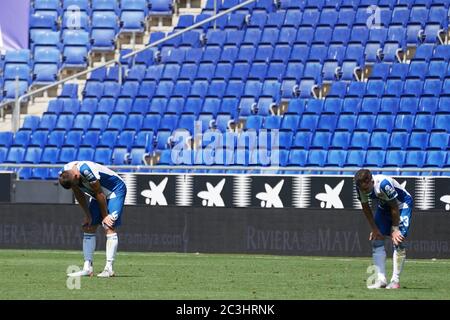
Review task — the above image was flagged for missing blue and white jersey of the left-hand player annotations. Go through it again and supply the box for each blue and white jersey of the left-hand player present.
[64,161,127,199]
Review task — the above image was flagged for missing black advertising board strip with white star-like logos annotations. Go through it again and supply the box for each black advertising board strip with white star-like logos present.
[6,173,450,213]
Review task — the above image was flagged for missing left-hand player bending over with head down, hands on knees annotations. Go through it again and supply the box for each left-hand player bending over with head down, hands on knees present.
[59,161,127,278]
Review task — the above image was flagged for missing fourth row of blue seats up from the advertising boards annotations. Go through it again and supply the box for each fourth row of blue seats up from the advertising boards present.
[17,96,450,117]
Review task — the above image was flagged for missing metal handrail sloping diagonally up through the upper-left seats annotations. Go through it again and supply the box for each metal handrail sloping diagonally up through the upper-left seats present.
[0,0,258,132]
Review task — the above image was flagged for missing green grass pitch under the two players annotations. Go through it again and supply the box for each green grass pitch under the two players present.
[0,250,450,300]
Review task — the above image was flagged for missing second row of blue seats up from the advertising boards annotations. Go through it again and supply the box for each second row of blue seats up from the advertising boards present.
[0,123,450,152]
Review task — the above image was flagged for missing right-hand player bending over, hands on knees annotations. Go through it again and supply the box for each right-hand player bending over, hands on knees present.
[355,169,413,289]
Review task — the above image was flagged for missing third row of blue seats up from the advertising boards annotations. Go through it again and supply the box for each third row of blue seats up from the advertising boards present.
[4,110,450,134]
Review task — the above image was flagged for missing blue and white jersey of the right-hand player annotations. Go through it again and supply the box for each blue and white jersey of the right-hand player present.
[356,174,413,209]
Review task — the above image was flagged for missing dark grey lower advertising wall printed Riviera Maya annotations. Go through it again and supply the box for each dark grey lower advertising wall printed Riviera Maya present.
[0,204,450,258]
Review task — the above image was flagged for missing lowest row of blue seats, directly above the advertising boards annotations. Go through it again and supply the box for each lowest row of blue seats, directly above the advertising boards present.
[0,147,450,179]
